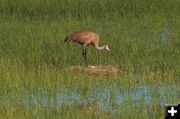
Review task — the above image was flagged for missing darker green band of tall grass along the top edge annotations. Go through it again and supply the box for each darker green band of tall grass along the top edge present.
[0,0,180,19]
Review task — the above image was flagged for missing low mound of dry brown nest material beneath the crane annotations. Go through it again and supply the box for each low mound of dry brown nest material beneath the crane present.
[68,65,119,74]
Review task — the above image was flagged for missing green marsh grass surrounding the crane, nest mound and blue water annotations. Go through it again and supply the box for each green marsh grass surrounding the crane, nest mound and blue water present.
[0,0,180,119]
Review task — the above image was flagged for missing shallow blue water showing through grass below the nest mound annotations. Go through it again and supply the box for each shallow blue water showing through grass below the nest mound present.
[0,84,178,112]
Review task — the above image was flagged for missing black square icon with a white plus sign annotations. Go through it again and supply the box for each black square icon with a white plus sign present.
[165,104,180,119]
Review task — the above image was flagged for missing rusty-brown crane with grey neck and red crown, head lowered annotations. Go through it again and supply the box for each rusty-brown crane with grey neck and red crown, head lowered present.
[64,30,111,63]
